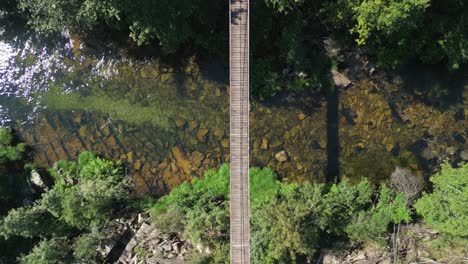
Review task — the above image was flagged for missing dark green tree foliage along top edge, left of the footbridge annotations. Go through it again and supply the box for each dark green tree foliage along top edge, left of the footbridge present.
[19,0,220,50]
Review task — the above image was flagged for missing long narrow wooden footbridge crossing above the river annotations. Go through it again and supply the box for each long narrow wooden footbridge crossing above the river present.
[229,0,250,264]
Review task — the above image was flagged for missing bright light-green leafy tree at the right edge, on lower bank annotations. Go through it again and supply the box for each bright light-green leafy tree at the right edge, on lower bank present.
[414,163,468,239]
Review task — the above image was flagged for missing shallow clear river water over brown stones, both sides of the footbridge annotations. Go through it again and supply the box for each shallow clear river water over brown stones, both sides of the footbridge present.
[0,15,468,195]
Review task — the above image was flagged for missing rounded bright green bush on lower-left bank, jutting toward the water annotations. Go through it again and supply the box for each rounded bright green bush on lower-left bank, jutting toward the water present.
[40,152,129,229]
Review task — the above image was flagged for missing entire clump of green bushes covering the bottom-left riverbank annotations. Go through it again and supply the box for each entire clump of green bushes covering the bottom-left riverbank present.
[0,152,130,263]
